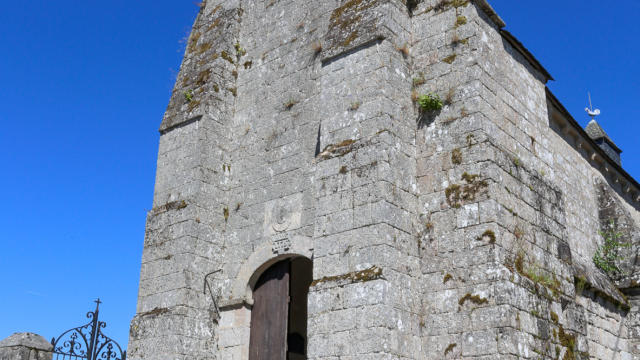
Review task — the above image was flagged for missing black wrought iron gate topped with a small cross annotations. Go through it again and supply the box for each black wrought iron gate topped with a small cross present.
[51,299,127,360]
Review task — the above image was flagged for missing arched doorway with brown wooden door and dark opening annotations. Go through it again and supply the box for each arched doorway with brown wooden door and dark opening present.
[249,257,312,360]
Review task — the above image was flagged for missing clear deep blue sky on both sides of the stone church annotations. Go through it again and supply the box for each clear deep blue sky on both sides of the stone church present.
[0,0,640,346]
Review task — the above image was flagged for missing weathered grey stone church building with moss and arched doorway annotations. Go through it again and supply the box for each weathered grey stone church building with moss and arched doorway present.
[129,0,640,360]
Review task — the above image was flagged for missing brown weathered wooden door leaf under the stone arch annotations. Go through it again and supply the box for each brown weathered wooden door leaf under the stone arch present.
[249,260,290,360]
